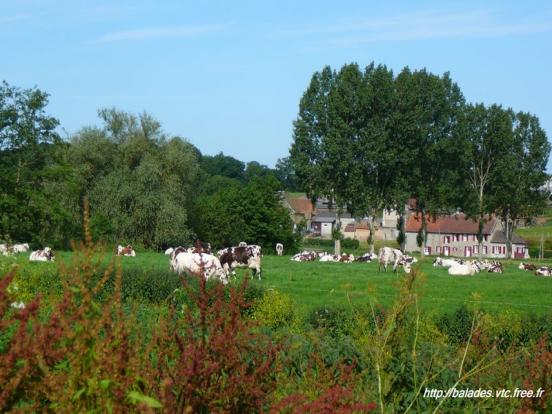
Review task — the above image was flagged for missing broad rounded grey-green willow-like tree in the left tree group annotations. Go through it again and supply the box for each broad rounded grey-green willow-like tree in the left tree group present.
[70,109,199,248]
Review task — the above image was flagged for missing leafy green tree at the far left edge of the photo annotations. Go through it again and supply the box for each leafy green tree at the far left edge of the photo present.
[0,82,80,246]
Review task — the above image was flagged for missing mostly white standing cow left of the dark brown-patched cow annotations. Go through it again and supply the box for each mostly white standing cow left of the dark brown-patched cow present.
[169,251,228,284]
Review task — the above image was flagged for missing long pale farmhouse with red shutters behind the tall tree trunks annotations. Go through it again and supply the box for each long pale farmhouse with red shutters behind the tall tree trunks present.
[405,213,529,259]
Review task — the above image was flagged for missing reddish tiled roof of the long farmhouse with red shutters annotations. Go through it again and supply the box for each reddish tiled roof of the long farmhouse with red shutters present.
[405,213,496,234]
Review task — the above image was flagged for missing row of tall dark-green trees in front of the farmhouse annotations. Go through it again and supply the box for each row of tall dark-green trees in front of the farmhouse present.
[289,63,550,253]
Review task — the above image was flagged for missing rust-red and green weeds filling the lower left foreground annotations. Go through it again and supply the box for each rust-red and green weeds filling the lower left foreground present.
[0,225,374,413]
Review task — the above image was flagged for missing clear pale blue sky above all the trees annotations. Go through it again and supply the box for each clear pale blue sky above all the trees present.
[0,0,552,171]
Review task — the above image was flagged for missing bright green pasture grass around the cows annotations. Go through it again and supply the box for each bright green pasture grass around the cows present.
[0,252,552,313]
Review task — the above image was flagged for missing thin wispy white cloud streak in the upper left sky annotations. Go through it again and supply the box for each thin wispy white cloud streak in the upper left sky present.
[94,24,227,43]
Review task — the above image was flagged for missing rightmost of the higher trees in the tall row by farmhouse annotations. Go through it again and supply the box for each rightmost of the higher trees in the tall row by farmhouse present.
[394,68,465,253]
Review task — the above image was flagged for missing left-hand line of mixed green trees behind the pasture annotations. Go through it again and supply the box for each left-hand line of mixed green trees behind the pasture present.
[0,82,296,249]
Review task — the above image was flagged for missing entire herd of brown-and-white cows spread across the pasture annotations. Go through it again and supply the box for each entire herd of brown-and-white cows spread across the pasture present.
[0,241,552,284]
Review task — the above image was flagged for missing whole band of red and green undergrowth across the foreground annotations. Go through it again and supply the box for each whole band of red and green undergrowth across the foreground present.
[0,233,552,413]
